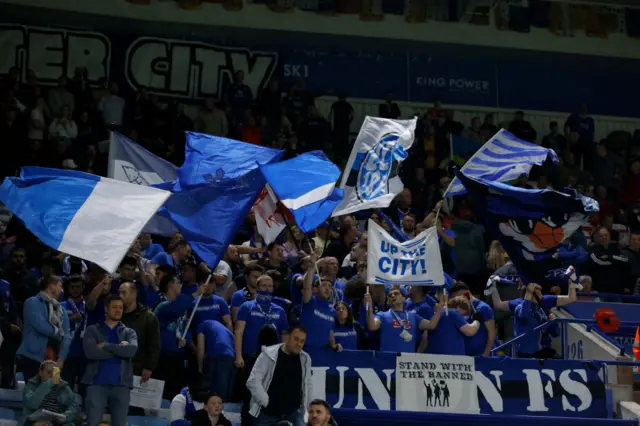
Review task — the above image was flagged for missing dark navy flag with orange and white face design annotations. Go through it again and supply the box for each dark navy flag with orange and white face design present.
[456,170,599,285]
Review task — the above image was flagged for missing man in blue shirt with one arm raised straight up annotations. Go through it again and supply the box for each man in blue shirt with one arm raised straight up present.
[300,253,342,352]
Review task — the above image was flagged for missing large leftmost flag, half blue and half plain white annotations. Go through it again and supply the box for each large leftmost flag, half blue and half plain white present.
[0,167,171,273]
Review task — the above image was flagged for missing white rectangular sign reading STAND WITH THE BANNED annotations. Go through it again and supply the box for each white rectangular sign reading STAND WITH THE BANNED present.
[396,353,480,414]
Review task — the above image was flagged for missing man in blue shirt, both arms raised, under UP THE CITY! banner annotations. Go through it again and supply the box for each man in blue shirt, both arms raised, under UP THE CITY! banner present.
[363,287,442,353]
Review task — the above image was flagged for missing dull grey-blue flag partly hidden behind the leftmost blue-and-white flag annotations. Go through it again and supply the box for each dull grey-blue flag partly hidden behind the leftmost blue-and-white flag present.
[107,132,178,236]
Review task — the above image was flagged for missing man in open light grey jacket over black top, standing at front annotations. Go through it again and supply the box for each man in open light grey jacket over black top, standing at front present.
[247,327,312,426]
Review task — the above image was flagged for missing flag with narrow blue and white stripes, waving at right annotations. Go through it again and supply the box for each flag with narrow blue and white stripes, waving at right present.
[443,129,560,197]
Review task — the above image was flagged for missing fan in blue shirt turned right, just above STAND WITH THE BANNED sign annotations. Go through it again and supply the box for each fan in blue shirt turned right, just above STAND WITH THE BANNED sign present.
[427,296,480,355]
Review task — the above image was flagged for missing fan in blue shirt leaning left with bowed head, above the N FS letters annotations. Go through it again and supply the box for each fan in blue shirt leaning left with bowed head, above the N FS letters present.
[449,281,496,356]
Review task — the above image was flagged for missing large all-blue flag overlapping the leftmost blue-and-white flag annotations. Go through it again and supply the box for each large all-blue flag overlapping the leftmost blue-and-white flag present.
[154,132,284,268]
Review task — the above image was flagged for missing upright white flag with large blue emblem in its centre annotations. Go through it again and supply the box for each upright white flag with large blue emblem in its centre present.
[333,117,417,216]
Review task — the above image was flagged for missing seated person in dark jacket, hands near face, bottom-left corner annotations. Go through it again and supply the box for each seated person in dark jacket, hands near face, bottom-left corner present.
[20,361,78,426]
